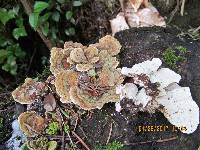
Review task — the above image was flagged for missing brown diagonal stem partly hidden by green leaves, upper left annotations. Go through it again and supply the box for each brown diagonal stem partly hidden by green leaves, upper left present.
[20,0,53,50]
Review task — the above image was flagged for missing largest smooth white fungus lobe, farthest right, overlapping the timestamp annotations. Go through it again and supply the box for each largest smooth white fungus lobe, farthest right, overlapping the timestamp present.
[157,87,199,134]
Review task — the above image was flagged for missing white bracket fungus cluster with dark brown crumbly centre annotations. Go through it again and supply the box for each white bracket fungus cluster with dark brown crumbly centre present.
[116,58,199,134]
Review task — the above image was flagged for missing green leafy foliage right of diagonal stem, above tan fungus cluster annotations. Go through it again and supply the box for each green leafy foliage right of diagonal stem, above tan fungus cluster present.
[29,0,82,44]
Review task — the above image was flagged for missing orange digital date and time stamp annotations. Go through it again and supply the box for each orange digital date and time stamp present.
[137,125,187,132]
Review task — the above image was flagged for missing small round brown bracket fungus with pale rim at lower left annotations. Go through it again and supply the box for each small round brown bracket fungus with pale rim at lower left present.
[18,111,45,137]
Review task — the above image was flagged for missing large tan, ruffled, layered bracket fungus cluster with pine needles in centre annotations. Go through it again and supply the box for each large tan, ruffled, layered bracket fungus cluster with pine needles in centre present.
[50,35,123,110]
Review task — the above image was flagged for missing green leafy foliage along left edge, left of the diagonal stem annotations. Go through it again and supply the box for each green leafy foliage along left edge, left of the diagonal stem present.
[0,5,27,75]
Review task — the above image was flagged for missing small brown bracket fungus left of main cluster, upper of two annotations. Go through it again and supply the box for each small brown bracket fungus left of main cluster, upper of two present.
[12,78,48,104]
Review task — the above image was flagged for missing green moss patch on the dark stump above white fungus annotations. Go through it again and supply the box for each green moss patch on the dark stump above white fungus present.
[163,46,188,69]
